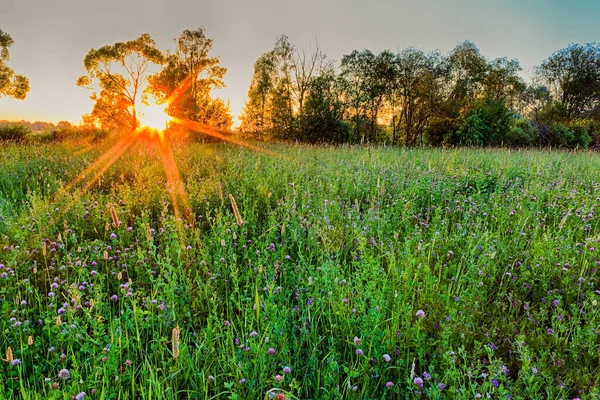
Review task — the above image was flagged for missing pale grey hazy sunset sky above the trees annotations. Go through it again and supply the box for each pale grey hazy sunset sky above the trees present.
[0,0,600,123]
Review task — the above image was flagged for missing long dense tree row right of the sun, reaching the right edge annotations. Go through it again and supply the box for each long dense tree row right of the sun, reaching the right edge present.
[240,35,600,148]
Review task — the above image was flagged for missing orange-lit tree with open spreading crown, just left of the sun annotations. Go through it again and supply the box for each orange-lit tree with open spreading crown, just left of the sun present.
[77,33,164,130]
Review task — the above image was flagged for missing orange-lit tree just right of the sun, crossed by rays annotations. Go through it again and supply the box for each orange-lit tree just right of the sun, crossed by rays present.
[150,27,233,128]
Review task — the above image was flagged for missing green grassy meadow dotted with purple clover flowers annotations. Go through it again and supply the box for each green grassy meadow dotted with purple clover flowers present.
[0,137,600,399]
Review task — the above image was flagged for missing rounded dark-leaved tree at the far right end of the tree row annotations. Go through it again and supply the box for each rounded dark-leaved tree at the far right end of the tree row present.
[537,43,600,121]
